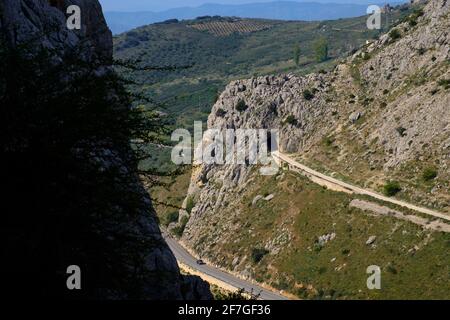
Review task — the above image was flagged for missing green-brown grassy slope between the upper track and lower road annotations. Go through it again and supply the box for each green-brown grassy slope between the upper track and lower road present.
[195,173,450,299]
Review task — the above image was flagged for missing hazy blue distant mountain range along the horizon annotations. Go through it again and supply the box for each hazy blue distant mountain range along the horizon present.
[105,0,398,34]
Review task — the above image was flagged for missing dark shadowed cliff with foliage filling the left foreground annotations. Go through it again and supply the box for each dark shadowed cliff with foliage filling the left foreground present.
[0,0,211,299]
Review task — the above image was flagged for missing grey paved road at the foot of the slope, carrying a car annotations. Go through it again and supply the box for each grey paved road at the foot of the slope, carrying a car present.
[163,233,288,300]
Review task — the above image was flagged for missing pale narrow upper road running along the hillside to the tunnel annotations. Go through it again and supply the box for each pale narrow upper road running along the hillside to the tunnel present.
[272,151,450,221]
